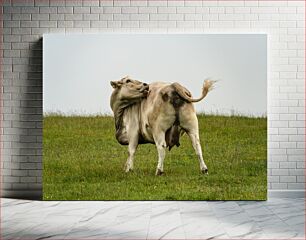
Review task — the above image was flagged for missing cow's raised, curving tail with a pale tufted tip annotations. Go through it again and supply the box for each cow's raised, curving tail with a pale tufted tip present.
[172,79,216,103]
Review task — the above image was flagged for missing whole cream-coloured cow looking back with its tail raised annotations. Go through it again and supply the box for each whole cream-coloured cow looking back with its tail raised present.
[110,76,214,175]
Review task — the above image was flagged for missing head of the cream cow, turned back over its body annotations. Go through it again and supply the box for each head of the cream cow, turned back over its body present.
[110,76,149,102]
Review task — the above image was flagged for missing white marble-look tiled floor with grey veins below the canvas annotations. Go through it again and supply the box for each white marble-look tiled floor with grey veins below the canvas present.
[1,198,305,240]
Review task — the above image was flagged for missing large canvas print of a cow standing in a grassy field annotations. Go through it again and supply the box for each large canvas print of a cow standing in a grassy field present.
[43,33,267,200]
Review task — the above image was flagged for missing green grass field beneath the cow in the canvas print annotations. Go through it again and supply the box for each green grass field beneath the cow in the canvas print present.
[43,115,267,200]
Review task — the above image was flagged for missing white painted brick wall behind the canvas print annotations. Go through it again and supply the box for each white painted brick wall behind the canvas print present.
[1,0,305,199]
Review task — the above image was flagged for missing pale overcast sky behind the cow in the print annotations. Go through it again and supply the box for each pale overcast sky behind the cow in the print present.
[43,33,267,116]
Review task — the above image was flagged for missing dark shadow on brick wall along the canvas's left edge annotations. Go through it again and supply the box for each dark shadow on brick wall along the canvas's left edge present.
[13,38,43,200]
